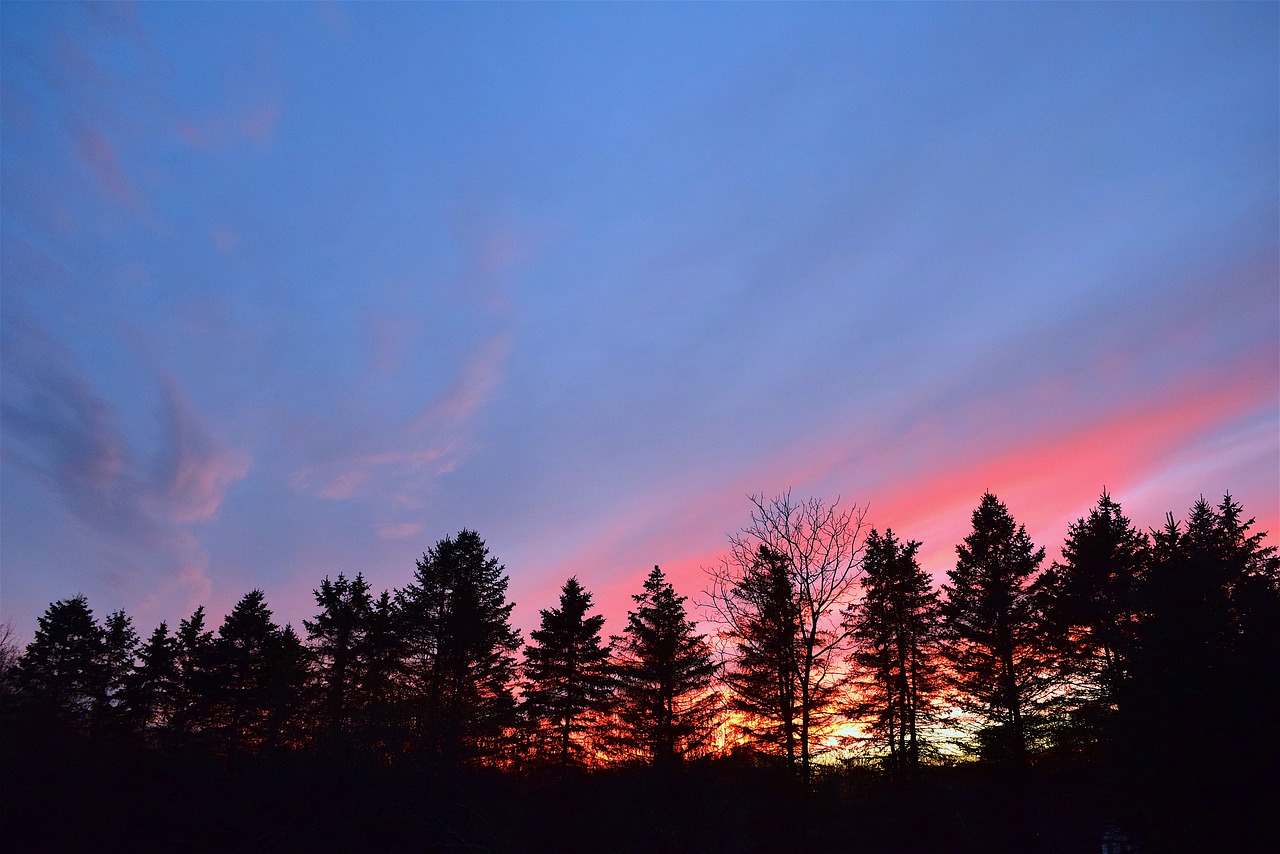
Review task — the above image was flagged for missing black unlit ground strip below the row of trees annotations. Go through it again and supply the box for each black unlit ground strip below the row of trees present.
[0,729,1280,854]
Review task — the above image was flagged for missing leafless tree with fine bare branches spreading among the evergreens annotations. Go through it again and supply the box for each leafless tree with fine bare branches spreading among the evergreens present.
[707,492,867,780]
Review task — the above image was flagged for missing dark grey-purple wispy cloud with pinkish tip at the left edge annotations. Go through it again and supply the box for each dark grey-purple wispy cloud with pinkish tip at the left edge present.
[0,312,250,602]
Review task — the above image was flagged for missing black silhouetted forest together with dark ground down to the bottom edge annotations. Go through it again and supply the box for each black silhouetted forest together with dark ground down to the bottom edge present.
[0,492,1280,853]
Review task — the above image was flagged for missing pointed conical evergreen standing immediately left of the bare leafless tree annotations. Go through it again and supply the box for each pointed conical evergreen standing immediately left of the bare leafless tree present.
[613,566,718,766]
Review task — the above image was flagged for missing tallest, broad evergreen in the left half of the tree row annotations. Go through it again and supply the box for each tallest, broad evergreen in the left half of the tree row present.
[397,530,521,764]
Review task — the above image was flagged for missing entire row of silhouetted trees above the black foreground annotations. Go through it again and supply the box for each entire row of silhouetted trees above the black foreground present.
[3,492,1280,793]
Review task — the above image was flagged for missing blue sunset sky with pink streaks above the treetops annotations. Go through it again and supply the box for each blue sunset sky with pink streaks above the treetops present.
[0,3,1280,640]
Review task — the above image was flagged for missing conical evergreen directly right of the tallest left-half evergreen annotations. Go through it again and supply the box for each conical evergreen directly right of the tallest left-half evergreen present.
[524,577,613,764]
